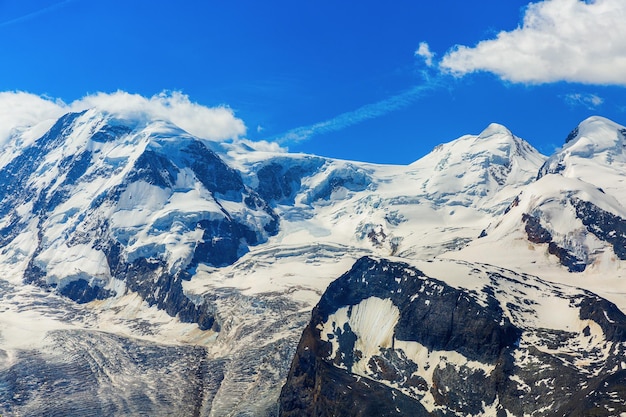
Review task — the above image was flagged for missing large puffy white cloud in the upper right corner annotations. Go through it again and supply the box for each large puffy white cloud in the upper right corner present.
[440,0,626,86]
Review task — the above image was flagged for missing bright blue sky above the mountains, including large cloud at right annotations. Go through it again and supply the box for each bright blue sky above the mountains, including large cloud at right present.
[0,0,626,164]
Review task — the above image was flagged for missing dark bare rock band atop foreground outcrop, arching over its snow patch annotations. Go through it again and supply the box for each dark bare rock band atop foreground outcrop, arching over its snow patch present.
[313,257,520,363]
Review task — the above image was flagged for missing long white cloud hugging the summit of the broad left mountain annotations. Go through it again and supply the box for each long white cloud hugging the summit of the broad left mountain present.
[71,91,246,141]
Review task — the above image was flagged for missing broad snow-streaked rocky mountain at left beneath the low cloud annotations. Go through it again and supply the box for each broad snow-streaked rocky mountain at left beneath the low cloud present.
[0,110,277,301]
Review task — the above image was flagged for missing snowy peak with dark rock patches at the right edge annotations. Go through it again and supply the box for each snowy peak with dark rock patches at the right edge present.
[446,117,626,292]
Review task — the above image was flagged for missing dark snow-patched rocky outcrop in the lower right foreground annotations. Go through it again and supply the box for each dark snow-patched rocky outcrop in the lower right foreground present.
[280,258,626,416]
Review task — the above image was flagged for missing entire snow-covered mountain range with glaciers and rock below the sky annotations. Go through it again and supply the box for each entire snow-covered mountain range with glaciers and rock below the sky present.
[0,108,626,416]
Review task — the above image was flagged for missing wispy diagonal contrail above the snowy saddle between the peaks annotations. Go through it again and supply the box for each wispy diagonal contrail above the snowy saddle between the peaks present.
[268,80,438,145]
